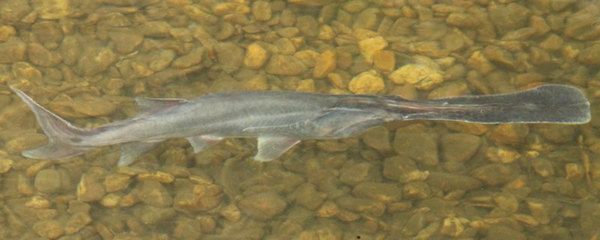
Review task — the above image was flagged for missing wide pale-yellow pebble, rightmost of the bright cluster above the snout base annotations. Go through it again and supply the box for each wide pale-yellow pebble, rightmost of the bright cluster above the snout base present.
[388,64,444,90]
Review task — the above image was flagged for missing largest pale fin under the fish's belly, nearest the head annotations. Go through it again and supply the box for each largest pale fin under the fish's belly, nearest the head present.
[254,137,300,162]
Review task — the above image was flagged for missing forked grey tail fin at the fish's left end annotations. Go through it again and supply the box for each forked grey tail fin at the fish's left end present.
[10,87,89,159]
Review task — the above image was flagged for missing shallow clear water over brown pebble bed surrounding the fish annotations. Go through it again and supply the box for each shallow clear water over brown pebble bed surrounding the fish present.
[0,0,600,240]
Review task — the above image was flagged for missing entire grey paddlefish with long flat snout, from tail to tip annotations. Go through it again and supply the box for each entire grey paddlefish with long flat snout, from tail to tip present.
[11,84,590,166]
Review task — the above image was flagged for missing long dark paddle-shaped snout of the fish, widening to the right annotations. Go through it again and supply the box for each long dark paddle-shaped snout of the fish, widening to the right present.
[386,84,591,124]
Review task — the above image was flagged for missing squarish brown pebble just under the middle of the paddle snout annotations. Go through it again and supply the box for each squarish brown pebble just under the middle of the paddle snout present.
[441,133,481,162]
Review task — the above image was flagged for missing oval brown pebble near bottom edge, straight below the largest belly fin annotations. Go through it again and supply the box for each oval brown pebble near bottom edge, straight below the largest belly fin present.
[239,192,287,221]
